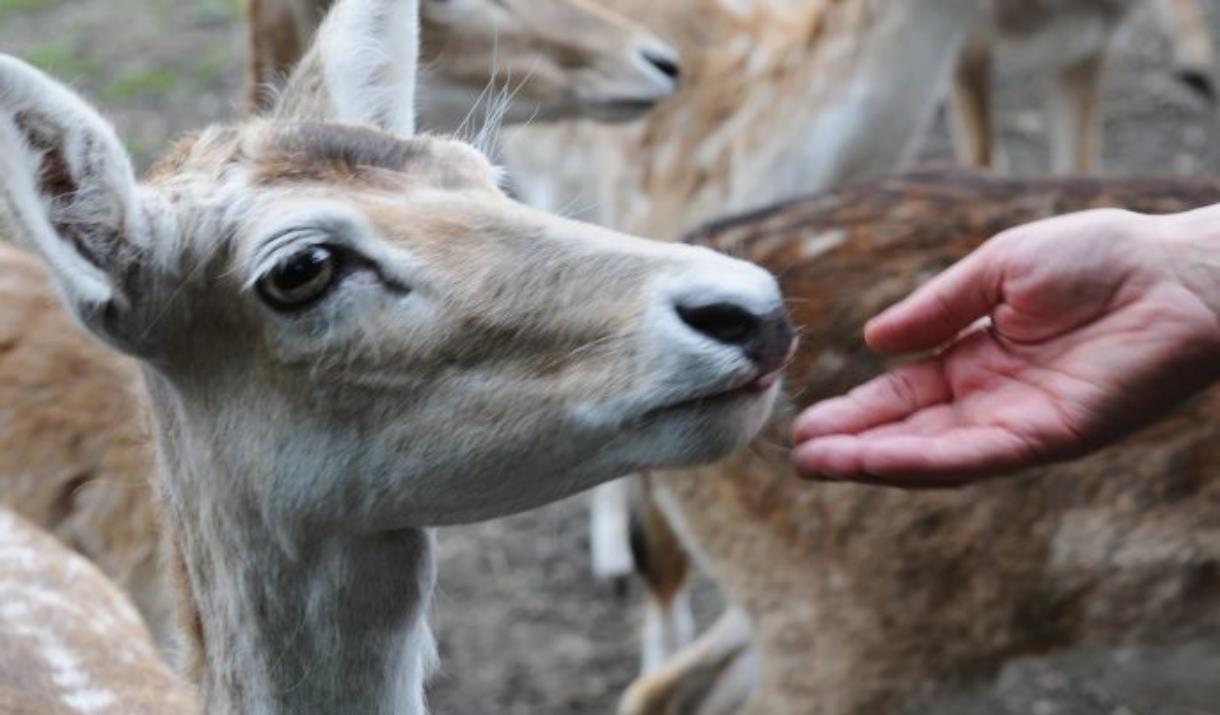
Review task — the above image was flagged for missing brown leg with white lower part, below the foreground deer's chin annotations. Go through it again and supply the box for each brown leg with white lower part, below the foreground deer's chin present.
[631,477,694,674]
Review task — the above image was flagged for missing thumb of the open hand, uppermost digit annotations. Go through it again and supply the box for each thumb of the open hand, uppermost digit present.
[864,237,1003,353]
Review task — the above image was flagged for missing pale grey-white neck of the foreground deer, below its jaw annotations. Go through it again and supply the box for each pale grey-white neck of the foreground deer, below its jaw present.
[150,373,436,715]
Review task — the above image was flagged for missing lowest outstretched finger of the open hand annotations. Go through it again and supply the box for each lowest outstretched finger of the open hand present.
[793,427,1046,480]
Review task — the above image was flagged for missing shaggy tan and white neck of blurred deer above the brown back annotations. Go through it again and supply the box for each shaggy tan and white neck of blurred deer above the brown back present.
[604,0,977,238]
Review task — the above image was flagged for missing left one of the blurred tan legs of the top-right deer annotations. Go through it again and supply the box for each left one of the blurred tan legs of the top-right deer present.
[953,30,994,168]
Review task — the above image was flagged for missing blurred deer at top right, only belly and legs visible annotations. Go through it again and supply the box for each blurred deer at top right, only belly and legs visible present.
[953,0,1214,174]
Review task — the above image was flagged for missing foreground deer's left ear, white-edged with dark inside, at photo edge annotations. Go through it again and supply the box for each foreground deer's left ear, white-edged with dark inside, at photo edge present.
[0,55,145,351]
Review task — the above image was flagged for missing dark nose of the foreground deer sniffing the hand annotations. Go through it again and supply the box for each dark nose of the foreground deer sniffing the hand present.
[676,301,795,373]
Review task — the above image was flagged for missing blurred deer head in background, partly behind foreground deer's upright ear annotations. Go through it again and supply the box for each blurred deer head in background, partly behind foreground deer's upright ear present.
[245,0,681,128]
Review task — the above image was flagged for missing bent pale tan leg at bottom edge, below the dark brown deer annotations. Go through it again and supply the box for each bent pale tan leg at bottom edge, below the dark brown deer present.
[619,608,759,715]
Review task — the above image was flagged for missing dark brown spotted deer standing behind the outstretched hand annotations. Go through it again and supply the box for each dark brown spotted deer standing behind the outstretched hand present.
[620,171,1220,715]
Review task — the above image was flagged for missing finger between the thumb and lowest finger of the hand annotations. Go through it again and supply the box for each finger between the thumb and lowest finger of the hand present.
[793,359,950,443]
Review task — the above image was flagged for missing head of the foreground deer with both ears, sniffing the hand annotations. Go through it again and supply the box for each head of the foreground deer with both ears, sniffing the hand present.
[0,0,791,526]
